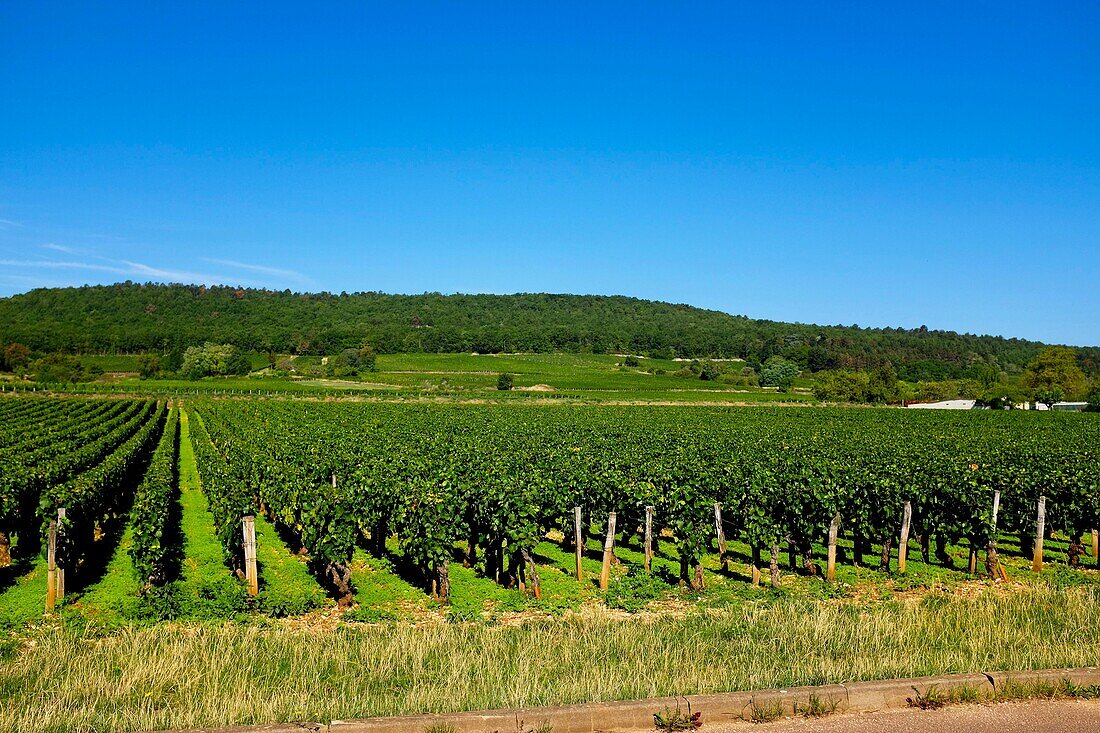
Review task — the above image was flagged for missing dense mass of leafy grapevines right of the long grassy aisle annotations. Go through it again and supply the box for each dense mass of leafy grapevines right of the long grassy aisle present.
[198,401,1100,594]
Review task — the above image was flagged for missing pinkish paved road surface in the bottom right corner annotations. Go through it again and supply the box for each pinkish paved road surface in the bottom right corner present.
[701,700,1100,733]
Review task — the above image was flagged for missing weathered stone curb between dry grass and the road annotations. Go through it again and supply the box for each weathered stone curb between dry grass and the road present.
[159,667,1100,733]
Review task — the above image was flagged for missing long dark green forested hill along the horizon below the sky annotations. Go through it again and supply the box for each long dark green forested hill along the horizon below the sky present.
[0,283,1100,380]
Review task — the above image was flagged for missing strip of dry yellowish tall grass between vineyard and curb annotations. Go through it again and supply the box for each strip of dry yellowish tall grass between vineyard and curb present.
[0,586,1100,733]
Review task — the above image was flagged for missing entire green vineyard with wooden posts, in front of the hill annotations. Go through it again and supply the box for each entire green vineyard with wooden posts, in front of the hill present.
[0,397,1100,620]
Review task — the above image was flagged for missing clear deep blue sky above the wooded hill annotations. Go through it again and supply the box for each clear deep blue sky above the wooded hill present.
[0,2,1100,344]
